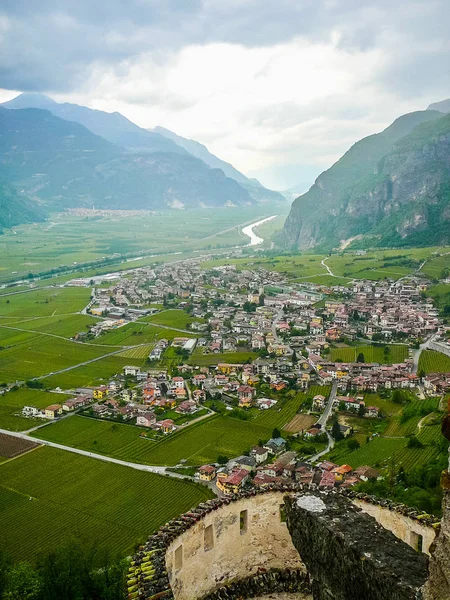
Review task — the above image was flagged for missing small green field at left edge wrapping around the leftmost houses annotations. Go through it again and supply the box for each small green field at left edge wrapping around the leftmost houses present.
[0,388,70,431]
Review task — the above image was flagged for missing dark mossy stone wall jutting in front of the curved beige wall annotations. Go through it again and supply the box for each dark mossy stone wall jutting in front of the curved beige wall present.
[285,491,428,600]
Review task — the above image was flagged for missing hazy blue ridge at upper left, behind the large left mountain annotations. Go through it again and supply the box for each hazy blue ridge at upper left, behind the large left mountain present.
[0,93,187,154]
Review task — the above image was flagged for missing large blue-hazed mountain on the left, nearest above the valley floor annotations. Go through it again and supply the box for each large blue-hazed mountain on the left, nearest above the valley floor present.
[0,107,253,209]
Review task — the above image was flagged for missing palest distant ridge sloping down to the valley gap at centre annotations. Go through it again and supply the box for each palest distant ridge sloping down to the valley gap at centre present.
[152,126,285,202]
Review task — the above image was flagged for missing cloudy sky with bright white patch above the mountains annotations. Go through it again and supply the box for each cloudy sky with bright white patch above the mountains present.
[0,0,450,191]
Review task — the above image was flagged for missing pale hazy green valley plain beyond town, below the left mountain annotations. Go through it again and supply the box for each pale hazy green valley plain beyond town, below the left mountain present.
[0,207,269,283]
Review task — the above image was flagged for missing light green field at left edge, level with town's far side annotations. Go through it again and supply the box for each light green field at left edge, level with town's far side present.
[0,288,91,318]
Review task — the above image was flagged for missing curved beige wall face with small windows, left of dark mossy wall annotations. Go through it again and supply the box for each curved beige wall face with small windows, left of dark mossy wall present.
[166,492,305,600]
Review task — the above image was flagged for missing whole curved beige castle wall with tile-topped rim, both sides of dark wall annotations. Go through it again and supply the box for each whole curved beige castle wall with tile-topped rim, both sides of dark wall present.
[128,483,439,600]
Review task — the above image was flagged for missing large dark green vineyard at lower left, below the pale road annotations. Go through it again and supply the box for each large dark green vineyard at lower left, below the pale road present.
[0,447,212,562]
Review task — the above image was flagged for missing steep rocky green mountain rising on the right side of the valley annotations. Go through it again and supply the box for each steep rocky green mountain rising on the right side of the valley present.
[279,110,450,250]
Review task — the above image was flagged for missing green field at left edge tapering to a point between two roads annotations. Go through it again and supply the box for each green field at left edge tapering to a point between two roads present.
[0,335,109,382]
